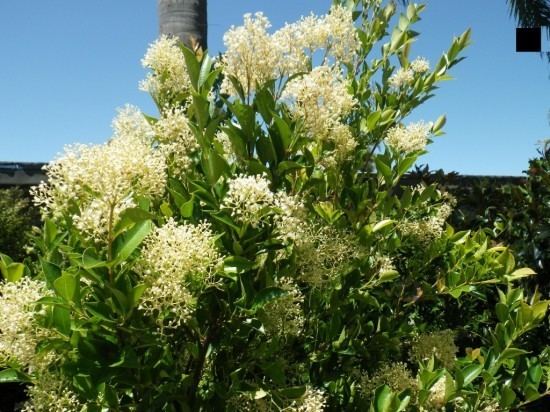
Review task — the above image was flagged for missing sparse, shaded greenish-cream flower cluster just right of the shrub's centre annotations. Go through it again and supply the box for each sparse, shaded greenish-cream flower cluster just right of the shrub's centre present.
[296,225,363,287]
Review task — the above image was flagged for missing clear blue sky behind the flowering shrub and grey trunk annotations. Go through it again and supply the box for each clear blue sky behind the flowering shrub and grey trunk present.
[0,0,550,175]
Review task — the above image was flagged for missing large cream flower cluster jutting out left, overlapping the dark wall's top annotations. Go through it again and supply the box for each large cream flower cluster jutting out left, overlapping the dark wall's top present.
[32,107,166,241]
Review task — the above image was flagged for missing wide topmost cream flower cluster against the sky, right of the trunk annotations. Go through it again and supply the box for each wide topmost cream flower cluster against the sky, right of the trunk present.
[222,6,360,95]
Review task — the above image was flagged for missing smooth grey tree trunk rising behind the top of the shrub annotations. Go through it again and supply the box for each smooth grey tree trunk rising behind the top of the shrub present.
[161,0,207,50]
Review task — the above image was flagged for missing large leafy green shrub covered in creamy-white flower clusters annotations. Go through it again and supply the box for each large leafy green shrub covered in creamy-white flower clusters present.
[0,0,549,412]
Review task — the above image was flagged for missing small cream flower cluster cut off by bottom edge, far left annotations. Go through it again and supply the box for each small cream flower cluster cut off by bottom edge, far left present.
[22,372,84,412]
